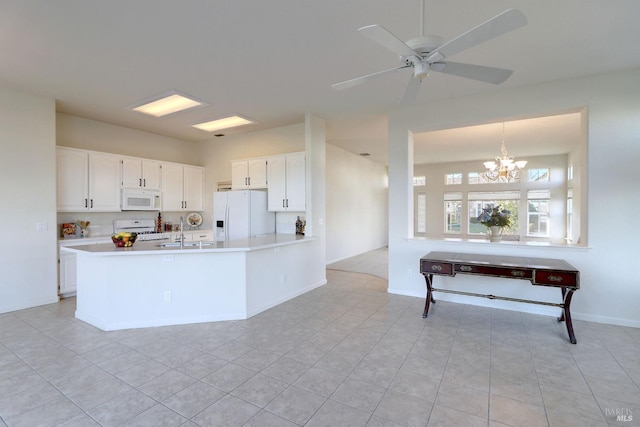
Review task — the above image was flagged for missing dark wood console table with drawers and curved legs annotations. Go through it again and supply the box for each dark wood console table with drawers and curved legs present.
[420,252,580,344]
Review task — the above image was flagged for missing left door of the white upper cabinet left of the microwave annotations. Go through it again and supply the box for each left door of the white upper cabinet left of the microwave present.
[56,148,89,212]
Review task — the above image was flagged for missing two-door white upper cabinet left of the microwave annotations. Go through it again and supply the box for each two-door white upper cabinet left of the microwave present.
[56,147,120,212]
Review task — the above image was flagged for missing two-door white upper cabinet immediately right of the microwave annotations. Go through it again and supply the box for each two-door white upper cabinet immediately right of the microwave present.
[162,163,204,212]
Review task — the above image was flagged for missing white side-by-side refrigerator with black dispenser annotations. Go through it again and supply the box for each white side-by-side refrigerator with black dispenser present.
[213,190,276,241]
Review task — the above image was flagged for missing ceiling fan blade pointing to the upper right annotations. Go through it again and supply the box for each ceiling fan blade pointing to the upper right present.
[427,9,527,62]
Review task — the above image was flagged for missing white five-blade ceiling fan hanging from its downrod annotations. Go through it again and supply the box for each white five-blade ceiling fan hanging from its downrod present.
[331,2,527,104]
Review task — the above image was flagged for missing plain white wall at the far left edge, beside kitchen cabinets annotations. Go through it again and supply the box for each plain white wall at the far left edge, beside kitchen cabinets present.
[0,87,58,313]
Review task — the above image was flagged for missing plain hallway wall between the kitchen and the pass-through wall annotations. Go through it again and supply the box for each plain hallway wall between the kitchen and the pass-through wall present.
[327,144,388,264]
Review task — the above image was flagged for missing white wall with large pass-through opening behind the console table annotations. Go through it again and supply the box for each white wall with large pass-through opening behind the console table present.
[389,69,640,328]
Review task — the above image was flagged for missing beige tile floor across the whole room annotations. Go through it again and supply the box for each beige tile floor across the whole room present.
[0,251,640,427]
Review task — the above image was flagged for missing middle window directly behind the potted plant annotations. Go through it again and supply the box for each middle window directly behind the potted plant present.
[469,191,520,234]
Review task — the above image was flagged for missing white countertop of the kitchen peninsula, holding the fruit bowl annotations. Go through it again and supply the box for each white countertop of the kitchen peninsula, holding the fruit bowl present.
[60,234,316,256]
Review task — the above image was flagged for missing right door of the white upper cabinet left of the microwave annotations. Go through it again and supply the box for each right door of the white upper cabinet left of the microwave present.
[89,153,121,212]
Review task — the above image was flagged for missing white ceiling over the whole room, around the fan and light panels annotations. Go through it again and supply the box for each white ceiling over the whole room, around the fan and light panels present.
[0,0,640,163]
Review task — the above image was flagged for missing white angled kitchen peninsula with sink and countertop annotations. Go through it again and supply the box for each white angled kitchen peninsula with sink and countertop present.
[61,234,326,331]
